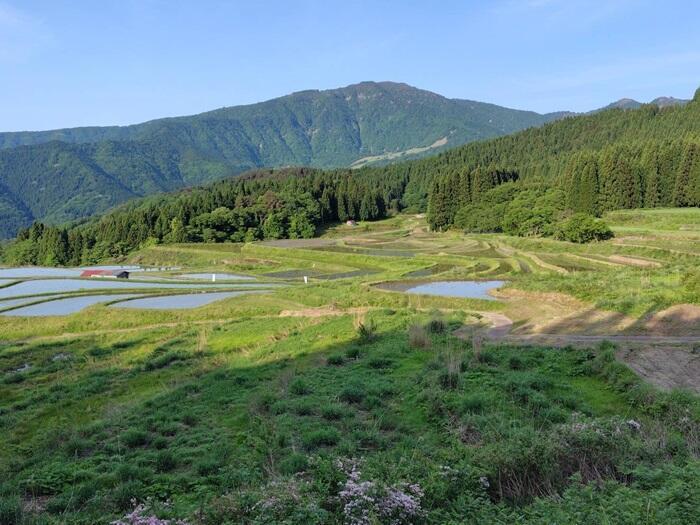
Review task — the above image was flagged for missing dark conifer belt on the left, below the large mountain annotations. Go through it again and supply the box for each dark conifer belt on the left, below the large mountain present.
[5,168,406,265]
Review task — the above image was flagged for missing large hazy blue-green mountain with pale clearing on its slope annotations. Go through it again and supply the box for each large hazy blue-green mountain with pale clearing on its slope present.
[0,82,683,238]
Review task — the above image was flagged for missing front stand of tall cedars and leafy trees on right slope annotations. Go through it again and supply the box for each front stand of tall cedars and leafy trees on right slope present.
[428,139,700,231]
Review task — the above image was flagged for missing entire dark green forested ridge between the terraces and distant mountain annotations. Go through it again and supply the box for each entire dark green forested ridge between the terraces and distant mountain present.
[7,90,700,264]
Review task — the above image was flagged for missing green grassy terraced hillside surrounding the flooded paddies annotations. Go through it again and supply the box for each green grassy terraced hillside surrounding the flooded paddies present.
[0,209,700,525]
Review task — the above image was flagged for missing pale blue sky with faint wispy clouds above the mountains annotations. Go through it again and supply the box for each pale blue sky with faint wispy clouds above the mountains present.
[0,0,700,131]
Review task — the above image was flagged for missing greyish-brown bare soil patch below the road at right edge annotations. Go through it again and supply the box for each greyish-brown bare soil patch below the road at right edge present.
[617,346,700,392]
